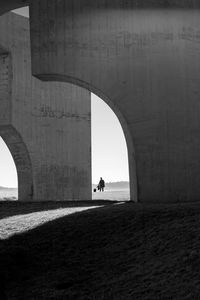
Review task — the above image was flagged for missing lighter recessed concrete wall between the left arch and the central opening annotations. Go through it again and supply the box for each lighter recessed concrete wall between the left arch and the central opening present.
[0,13,91,201]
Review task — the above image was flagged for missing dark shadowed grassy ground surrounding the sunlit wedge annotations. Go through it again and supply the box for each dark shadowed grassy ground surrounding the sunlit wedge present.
[0,202,200,300]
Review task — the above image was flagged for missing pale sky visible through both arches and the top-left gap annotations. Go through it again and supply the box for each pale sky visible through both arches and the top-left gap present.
[0,8,129,187]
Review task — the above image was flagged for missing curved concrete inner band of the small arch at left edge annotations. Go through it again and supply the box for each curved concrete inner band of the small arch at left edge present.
[0,125,33,201]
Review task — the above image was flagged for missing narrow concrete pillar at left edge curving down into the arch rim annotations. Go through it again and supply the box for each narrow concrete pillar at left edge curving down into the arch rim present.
[0,53,33,201]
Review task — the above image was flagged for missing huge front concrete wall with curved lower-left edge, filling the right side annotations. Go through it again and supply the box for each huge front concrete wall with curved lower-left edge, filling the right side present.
[27,0,200,202]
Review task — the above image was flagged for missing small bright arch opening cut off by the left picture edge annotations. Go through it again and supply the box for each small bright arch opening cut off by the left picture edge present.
[0,137,18,201]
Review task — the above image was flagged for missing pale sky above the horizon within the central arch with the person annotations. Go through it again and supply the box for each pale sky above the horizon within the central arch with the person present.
[91,94,129,183]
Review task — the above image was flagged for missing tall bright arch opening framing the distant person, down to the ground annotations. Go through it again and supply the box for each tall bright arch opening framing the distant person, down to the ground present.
[91,94,130,201]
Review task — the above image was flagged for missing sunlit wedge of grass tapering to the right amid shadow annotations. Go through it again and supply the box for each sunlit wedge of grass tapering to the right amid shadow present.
[0,206,98,239]
